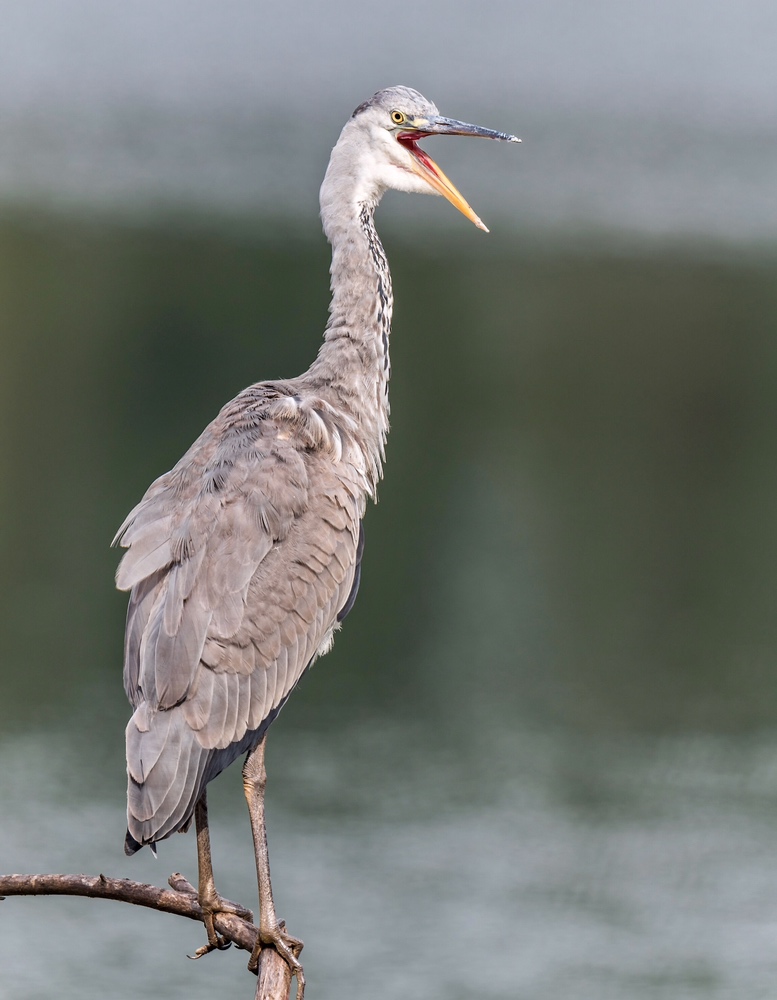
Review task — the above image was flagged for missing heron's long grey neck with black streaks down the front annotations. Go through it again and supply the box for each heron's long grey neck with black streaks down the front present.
[306,165,394,485]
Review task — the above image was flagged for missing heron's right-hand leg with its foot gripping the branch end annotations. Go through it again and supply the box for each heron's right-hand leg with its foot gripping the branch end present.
[243,736,305,1000]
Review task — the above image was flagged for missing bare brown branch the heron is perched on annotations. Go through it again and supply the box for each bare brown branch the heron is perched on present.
[0,873,291,1000]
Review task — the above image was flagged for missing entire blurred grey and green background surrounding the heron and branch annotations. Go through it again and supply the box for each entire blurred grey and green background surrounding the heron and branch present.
[0,0,777,1000]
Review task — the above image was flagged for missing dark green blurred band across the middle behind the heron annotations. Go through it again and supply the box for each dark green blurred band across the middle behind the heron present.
[0,215,777,731]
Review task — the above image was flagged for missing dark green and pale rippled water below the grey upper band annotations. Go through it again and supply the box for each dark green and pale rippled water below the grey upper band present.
[0,214,777,1000]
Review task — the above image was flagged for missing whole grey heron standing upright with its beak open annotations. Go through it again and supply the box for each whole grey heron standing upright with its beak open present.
[114,86,520,1000]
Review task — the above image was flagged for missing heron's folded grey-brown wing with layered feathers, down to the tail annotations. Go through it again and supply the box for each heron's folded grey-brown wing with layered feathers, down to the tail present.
[117,410,361,849]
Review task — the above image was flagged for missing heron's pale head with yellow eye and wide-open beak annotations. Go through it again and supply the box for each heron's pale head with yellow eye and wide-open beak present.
[322,87,521,232]
